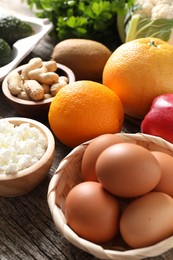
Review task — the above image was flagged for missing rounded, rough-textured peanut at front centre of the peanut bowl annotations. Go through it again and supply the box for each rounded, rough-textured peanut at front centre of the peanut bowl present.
[24,79,44,101]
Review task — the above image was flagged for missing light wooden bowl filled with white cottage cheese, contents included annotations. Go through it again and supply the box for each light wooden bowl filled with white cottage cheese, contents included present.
[0,117,55,197]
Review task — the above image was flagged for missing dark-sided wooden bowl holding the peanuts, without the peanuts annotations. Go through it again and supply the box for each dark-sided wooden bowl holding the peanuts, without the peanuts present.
[2,63,75,121]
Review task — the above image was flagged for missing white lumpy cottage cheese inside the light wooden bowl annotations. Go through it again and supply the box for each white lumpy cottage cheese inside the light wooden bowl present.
[0,119,47,174]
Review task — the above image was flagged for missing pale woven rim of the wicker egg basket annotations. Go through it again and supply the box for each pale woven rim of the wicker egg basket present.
[47,133,173,260]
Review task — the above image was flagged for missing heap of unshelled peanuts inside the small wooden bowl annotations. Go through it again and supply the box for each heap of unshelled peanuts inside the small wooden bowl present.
[7,57,68,101]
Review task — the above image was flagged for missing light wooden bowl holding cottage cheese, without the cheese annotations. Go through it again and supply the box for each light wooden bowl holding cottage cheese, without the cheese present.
[0,117,55,197]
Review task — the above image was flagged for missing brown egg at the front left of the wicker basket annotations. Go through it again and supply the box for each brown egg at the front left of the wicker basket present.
[65,181,119,243]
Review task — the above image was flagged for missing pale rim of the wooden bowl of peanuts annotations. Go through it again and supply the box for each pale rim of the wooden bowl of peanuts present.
[2,63,75,106]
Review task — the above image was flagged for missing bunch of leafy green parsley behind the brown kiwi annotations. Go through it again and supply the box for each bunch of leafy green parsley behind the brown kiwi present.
[27,0,133,49]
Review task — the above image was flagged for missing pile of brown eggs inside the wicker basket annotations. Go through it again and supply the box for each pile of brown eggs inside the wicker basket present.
[58,134,173,248]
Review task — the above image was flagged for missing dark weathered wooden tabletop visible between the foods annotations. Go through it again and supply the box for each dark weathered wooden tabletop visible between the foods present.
[0,0,173,260]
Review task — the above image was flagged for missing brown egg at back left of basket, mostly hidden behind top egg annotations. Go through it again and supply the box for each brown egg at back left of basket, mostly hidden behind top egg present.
[81,134,123,181]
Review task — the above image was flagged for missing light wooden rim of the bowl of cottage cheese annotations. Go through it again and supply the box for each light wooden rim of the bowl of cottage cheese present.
[0,117,55,181]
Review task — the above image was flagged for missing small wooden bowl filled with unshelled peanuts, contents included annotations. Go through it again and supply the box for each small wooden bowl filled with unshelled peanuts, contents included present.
[2,57,75,121]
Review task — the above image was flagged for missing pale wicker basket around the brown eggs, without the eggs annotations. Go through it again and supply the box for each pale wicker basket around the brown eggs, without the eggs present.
[48,133,173,260]
